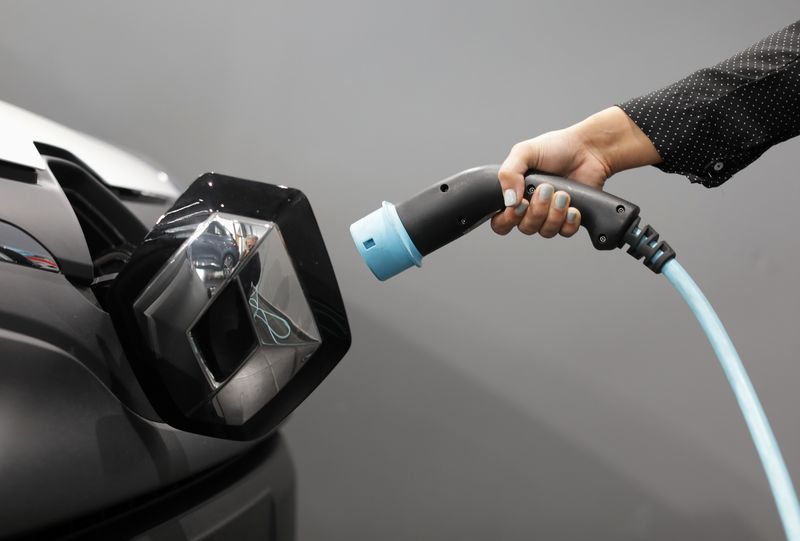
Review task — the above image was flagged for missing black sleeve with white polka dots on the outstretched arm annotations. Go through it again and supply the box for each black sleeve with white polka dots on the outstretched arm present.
[620,21,800,188]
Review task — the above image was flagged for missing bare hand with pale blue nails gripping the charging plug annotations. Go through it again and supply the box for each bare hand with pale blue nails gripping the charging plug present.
[492,107,661,238]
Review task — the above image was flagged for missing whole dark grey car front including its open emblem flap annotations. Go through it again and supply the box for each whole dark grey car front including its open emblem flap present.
[0,102,350,540]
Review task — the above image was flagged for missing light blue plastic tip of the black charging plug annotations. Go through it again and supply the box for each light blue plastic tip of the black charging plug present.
[350,201,422,280]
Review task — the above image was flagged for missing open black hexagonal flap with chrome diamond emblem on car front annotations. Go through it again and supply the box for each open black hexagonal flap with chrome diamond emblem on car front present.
[108,173,350,439]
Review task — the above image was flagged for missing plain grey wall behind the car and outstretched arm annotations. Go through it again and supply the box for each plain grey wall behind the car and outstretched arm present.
[0,0,800,541]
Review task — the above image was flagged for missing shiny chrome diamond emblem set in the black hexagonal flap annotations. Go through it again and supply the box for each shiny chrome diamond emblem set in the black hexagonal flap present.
[134,213,321,425]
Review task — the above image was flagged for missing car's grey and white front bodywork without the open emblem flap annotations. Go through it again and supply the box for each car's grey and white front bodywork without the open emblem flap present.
[0,102,350,540]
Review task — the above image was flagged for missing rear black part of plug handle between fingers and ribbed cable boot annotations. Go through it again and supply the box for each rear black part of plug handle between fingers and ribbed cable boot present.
[525,171,639,250]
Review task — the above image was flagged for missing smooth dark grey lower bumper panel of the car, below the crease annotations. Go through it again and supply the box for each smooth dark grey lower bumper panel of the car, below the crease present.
[0,324,264,535]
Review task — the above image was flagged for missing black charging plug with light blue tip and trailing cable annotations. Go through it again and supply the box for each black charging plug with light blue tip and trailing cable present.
[350,166,800,541]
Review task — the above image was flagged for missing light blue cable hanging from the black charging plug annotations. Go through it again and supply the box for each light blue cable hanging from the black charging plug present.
[661,259,800,541]
